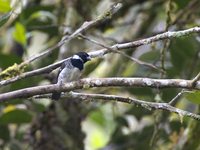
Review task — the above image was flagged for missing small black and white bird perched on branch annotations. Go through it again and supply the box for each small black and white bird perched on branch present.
[52,52,91,100]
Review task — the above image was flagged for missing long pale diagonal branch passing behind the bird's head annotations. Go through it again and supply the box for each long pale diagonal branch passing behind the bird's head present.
[0,27,200,86]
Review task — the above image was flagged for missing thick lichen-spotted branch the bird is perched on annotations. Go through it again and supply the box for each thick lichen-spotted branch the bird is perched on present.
[0,78,200,102]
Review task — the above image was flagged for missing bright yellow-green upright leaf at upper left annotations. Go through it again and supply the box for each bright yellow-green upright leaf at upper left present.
[13,22,26,46]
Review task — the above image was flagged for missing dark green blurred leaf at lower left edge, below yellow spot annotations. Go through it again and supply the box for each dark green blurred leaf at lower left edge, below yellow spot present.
[0,109,32,124]
